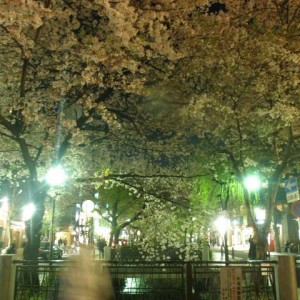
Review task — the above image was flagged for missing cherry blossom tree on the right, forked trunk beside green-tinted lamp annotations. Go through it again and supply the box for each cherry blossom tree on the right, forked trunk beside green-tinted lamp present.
[180,1,300,258]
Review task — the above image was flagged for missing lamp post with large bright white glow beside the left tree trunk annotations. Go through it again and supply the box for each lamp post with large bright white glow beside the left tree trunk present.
[46,165,67,260]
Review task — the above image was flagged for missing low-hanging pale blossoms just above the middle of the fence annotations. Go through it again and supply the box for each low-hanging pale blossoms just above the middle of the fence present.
[137,199,211,260]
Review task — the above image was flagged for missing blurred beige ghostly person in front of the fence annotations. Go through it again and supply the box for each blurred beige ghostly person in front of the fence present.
[59,247,114,300]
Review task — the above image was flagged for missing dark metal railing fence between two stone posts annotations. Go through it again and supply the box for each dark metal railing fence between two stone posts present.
[14,261,276,300]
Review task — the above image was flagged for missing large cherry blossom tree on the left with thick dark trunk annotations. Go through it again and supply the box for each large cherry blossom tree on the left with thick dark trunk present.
[0,0,206,259]
